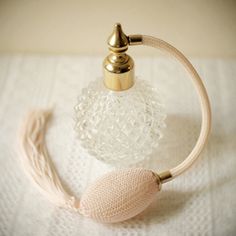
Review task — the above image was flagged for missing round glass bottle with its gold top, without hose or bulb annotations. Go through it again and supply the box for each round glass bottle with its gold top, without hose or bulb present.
[75,24,166,165]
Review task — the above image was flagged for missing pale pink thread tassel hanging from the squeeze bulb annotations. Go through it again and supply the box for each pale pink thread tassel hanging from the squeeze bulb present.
[20,110,79,211]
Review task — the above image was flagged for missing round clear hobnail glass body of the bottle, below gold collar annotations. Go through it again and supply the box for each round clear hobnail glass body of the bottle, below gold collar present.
[75,79,166,165]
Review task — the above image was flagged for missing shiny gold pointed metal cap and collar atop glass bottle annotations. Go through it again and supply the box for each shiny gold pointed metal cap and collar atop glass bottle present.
[103,23,134,91]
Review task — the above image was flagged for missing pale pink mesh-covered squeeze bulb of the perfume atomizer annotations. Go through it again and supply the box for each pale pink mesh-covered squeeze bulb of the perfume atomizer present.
[80,168,160,223]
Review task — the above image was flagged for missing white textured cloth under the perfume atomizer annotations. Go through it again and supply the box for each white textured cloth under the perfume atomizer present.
[0,55,236,236]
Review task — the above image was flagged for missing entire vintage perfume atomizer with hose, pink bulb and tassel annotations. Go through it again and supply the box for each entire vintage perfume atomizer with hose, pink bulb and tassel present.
[20,24,211,223]
